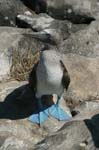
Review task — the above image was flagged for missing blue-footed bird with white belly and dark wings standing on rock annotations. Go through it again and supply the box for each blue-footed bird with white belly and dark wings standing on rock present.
[29,49,71,125]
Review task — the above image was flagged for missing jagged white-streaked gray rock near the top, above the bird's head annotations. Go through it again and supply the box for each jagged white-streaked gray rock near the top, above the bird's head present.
[17,13,86,34]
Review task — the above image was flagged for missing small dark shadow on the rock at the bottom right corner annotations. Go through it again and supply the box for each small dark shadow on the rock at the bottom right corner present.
[85,114,99,148]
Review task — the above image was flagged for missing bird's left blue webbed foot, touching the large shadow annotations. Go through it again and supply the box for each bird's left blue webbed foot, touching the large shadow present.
[28,109,48,125]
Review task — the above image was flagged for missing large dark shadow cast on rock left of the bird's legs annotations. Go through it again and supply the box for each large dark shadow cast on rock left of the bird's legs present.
[0,85,37,120]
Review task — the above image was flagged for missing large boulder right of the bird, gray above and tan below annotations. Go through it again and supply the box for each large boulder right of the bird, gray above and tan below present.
[56,21,99,105]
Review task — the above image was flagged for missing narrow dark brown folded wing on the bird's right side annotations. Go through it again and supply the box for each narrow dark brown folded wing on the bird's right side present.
[60,60,70,90]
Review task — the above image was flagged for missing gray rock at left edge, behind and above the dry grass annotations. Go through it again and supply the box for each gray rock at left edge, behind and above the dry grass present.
[0,27,44,81]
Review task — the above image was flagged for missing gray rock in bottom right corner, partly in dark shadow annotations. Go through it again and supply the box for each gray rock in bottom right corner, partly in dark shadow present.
[35,110,99,150]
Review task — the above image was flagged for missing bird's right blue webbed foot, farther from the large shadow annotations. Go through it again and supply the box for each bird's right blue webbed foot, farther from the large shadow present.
[49,104,71,121]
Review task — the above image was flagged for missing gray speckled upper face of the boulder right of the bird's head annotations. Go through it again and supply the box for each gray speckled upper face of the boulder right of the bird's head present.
[60,21,99,58]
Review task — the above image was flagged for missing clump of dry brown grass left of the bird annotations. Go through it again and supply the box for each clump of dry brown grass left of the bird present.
[10,49,39,81]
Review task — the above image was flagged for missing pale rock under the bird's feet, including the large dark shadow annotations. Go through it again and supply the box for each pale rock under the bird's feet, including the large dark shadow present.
[0,81,69,150]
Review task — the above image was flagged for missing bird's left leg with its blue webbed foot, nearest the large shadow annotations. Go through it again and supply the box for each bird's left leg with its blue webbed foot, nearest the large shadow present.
[29,98,48,125]
